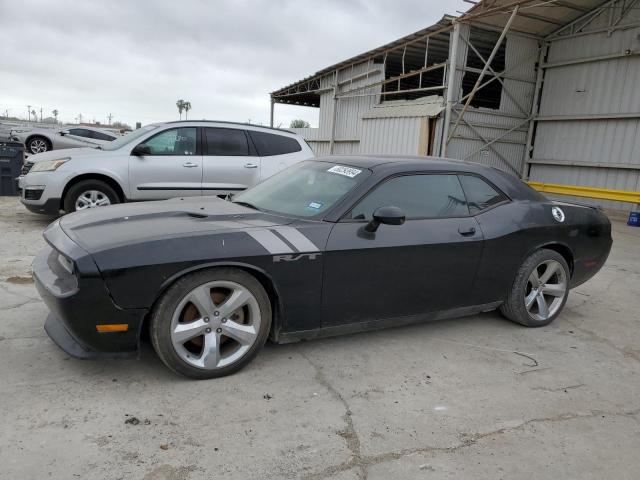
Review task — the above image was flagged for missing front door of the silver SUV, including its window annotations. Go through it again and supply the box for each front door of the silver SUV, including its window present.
[129,127,202,200]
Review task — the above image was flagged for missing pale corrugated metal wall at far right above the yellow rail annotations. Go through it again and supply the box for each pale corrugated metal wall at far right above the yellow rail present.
[529,3,640,210]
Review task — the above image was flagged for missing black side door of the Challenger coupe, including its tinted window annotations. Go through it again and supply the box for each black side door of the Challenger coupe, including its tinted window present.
[322,174,483,326]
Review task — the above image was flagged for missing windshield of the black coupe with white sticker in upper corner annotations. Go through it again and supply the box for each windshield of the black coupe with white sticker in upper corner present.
[232,162,370,217]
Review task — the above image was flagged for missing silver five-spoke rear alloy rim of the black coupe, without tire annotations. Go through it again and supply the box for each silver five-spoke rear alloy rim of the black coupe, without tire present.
[524,260,567,321]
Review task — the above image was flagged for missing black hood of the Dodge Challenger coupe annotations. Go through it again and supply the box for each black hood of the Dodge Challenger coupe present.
[59,197,293,253]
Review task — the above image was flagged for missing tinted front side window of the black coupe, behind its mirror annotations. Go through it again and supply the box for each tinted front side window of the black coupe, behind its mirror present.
[347,174,469,221]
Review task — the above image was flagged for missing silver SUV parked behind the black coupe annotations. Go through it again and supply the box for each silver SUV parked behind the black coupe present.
[19,121,313,214]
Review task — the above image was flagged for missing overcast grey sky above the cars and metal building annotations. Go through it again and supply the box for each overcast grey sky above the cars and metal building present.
[0,0,470,127]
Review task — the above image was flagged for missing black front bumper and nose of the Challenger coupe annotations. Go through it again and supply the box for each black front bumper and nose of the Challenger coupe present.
[33,227,147,358]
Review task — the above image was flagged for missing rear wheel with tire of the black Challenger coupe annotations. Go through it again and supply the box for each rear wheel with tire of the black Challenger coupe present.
[500,249,571,327]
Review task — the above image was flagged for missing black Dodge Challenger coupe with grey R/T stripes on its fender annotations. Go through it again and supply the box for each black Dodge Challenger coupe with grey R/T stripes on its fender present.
[33,156,611,378]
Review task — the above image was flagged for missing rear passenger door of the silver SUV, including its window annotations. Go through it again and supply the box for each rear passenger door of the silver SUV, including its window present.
[202,127,260,195]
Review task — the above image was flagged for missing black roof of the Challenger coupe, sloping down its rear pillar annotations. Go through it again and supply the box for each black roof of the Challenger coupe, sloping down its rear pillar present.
[310,155,546,201]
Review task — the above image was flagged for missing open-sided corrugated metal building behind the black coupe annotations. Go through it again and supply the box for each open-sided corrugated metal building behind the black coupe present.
[271,0,640,209]
